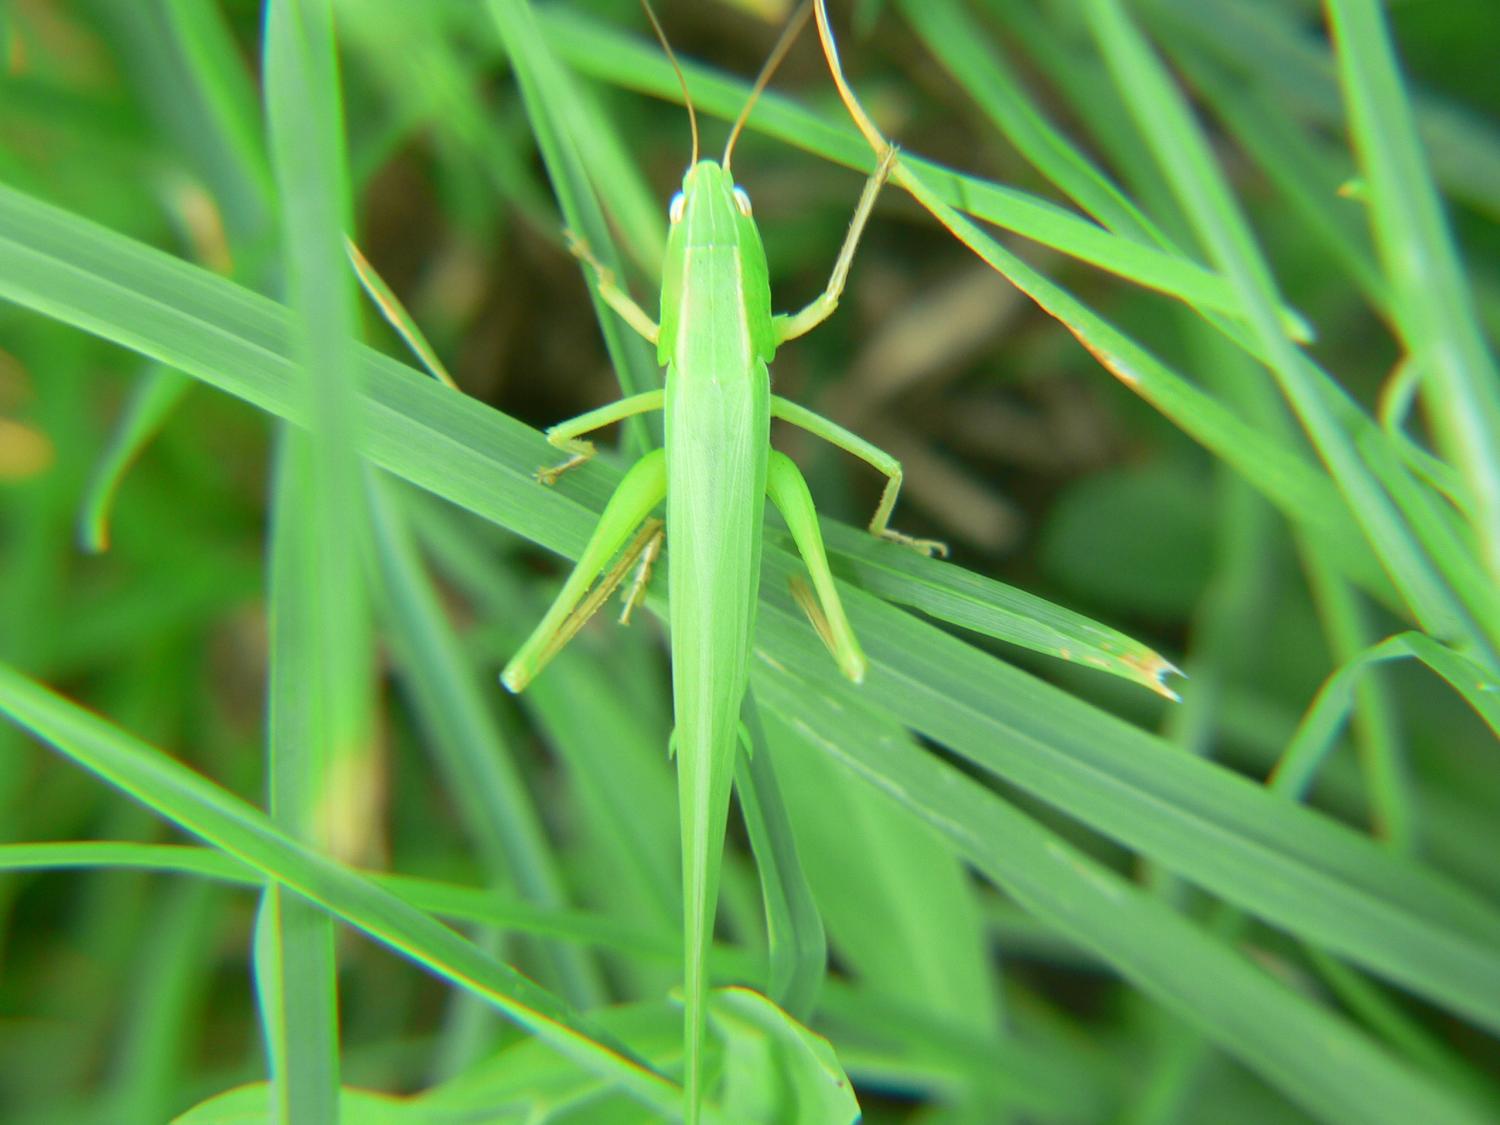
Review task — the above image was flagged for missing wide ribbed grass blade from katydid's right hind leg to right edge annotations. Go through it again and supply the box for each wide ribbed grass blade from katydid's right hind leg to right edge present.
[761,552,1500,1026]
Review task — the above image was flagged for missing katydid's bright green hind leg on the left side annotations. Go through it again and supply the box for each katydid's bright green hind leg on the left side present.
[500,450,666,692]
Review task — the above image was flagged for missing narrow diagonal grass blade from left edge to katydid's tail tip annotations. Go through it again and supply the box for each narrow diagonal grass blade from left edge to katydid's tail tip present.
[0,665,683,1113]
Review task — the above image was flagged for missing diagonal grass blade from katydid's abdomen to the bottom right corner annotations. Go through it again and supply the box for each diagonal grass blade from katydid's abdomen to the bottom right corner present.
[756,660,1481,1124]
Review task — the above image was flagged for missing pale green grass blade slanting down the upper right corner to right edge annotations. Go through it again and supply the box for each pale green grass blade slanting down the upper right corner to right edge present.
[1328,0,1500,585]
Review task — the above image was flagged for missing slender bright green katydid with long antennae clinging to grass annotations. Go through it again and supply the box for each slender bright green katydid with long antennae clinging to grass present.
[501,0,944,1121]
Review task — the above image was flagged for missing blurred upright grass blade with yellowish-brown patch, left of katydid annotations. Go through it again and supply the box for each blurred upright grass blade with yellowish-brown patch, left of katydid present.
[255,0,375,1125]
